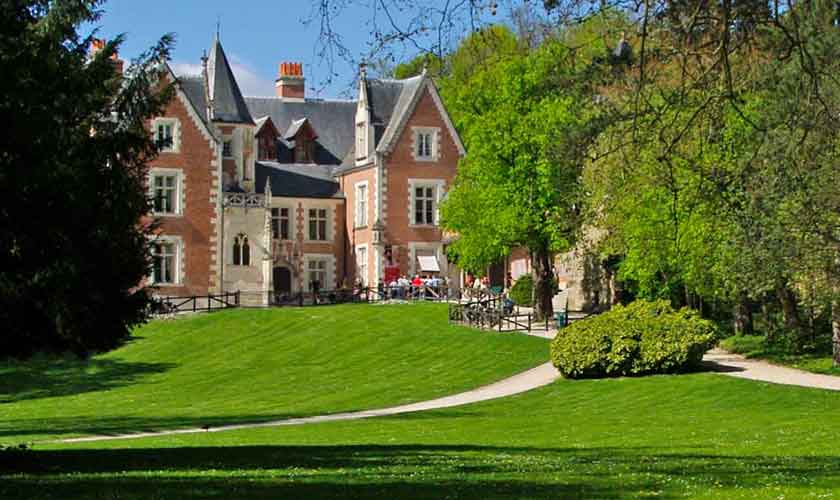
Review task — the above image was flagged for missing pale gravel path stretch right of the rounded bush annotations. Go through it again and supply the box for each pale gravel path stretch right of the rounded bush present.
[703,349,840,391]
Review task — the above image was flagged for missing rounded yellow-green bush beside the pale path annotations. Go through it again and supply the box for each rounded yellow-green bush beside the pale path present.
[551,300,716,378]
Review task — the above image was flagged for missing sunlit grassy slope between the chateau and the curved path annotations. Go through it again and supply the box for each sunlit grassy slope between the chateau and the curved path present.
[0,304,548,444]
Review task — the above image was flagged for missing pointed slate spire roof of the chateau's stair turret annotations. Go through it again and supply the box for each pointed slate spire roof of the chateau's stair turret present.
[207,38,254,123]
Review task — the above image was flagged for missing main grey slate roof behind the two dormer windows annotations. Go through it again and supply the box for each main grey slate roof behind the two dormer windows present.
[245,97,356,165]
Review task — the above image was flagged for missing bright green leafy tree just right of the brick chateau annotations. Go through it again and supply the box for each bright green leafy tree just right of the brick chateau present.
[441,43,604,317]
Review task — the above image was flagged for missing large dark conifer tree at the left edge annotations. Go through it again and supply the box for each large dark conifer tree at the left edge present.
[0,0,172,356]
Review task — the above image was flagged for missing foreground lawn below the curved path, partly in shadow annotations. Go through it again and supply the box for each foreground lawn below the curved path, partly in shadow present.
[0,373,840,500]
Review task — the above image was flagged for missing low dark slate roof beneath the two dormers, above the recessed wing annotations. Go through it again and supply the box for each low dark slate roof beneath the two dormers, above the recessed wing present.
[255,161,344,198]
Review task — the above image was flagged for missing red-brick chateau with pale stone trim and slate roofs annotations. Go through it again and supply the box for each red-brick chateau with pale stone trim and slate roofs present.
[148,39,465,303]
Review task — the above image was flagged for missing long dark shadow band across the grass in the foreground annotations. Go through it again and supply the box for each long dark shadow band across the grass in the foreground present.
[0,444,840,499]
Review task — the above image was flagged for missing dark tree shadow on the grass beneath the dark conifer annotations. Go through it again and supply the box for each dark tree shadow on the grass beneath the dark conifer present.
[0,358,176,404]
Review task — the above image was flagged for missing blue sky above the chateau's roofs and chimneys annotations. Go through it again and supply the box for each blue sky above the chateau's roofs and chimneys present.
[90,0,506,97]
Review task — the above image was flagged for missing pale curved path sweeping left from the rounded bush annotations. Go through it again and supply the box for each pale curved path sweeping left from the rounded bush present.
[62,363,560,443]
